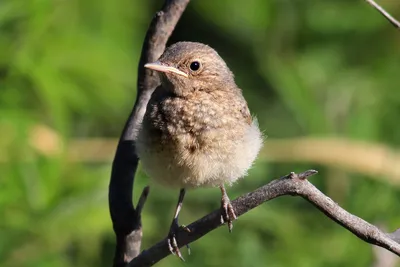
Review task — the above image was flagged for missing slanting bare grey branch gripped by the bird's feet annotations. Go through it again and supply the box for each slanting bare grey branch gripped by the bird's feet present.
[128,170,400,267]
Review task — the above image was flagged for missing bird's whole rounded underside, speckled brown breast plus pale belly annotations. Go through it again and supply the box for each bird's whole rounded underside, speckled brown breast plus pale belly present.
[137,91,261,187]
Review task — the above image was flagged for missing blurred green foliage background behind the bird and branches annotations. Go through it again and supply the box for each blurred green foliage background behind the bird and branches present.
[0,0,400,267]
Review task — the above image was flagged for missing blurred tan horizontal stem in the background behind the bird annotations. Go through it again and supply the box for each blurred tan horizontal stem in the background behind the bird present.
[7,126,400,186]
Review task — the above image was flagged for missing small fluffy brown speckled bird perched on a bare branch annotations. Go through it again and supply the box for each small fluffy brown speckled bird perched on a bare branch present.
[137,42,262,259]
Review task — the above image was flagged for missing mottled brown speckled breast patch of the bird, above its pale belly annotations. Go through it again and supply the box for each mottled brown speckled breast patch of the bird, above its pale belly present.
[157,94,245,147]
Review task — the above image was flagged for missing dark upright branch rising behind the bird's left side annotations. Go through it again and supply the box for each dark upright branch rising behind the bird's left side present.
[109,0,189,267]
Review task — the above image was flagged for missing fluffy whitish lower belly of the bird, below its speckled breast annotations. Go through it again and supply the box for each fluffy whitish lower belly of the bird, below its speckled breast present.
[137,120,263,188]
